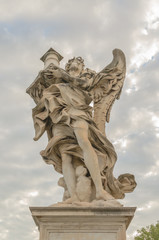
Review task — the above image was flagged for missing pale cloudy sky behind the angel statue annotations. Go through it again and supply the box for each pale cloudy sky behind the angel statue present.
[0,0,159,240]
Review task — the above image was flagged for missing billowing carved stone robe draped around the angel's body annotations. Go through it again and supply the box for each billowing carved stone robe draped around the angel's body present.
[33,79,124,198]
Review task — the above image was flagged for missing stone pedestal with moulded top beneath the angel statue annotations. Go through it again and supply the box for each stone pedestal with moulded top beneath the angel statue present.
[30,207,136,240]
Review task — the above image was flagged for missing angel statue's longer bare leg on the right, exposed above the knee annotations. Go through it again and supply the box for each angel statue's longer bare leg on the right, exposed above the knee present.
[74,120,114,200]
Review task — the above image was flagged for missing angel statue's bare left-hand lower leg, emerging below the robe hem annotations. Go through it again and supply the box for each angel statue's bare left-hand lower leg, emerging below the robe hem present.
[61,153,79,203]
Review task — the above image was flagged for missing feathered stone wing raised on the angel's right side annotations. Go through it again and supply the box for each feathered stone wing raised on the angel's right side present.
[93,49,126,135]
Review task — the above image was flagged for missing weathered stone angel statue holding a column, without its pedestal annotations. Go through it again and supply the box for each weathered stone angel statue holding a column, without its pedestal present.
[27,48,136,204]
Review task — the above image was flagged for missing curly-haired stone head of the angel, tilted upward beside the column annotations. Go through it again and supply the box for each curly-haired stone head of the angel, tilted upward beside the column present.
[65,57,84,75]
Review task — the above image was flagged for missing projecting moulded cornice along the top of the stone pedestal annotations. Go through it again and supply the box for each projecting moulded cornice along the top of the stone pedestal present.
[30,207,136,229]
